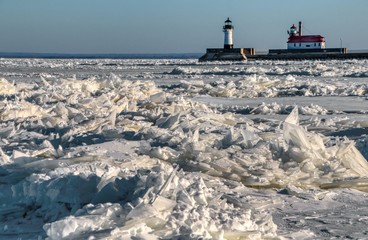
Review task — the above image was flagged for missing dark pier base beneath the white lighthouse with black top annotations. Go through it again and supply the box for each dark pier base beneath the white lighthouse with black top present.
[199,48,253,62]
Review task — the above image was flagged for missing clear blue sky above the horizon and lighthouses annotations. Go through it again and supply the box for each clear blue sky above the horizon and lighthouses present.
[0,0,368,53]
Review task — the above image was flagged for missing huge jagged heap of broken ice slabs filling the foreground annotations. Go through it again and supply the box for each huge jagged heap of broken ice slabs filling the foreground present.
[0,76,368,239]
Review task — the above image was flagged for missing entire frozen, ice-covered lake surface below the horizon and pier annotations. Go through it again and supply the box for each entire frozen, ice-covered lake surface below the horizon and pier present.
[0,59,368,239]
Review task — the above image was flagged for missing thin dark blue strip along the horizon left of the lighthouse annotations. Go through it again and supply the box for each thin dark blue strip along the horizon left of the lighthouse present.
[0,52,202,59]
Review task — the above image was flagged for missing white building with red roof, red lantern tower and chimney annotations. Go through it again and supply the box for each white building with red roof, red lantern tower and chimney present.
[287,22,326,49]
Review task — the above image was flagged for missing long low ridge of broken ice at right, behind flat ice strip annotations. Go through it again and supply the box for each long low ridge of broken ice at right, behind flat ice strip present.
[170,74,368,98]
